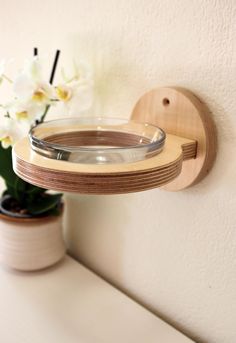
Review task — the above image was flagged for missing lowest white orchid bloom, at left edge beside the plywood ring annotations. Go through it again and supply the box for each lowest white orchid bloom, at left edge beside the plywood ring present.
[0,117,29,149]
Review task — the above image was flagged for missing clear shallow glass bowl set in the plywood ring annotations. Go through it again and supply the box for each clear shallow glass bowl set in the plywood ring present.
[29,117,166,164]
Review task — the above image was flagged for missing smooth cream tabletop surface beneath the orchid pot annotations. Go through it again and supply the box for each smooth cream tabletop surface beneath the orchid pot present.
[0,257,193,343]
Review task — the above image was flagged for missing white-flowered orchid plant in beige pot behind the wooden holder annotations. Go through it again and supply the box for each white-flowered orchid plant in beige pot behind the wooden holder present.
[0,49,93,270]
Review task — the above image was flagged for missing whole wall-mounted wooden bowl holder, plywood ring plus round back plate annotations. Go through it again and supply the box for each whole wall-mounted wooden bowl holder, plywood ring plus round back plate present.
[13,88,216,194]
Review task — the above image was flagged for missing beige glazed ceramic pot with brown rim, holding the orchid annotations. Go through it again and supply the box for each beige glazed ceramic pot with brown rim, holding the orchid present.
[0,214,66,271]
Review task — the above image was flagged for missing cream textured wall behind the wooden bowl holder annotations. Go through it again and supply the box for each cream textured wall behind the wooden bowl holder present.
[0,0,236,343]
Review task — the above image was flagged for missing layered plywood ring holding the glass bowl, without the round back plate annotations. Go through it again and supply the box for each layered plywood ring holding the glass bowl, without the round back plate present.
[13,135,196,194]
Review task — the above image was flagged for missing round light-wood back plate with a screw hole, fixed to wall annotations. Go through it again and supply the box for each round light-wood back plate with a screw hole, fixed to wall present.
[131,87,216,191]
